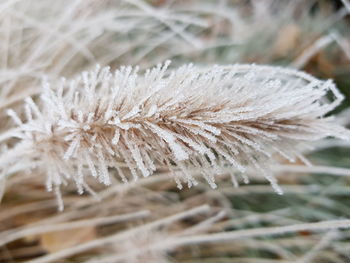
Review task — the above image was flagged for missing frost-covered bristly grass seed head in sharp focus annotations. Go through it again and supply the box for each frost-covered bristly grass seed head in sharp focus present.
[0,62,348,204]
